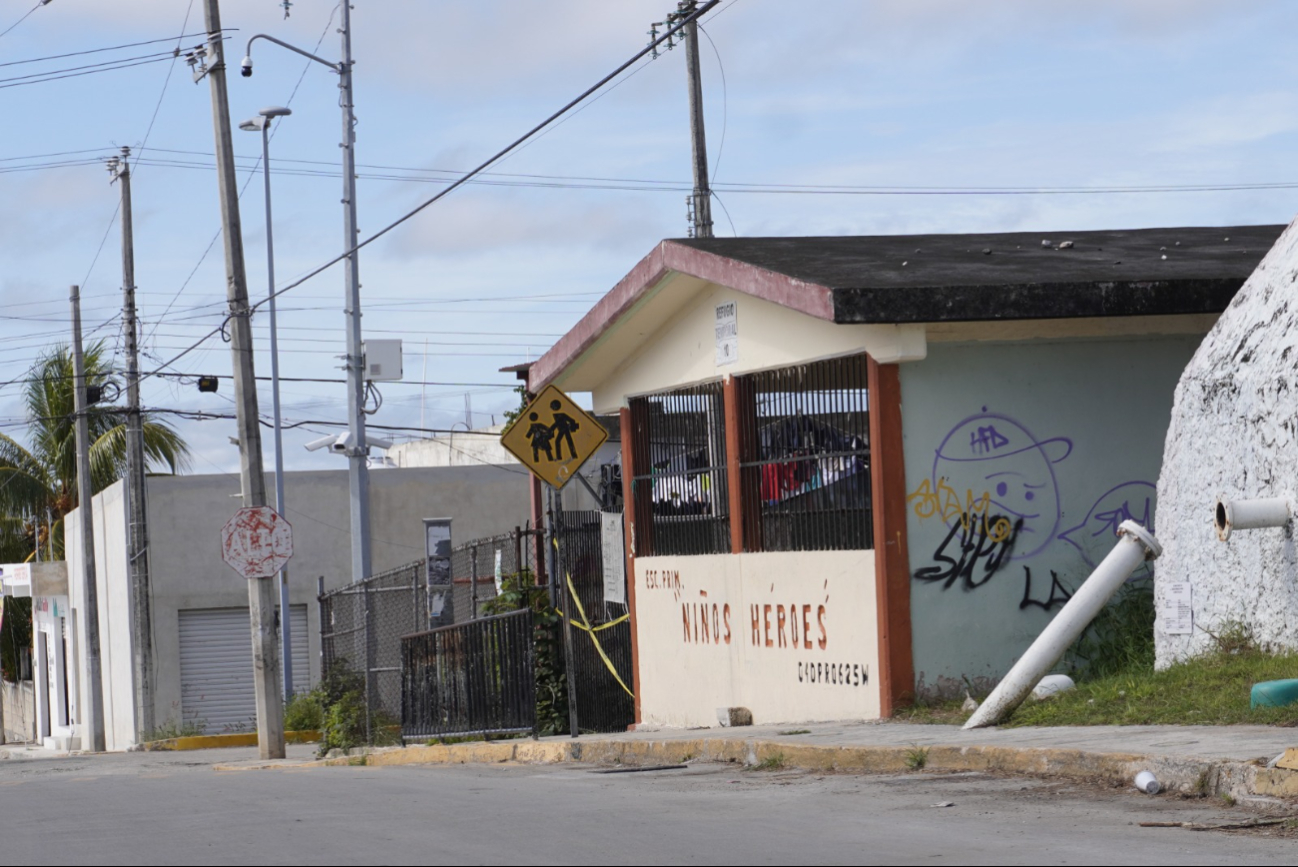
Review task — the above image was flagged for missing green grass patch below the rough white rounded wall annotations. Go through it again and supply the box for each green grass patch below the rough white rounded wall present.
[1005,641,1298,726]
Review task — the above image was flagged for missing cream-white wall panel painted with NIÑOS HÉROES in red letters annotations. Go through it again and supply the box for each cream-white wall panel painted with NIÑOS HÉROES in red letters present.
[635,550,879,727]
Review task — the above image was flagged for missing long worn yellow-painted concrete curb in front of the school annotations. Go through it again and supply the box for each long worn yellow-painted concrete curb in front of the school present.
[303,737,1298,797]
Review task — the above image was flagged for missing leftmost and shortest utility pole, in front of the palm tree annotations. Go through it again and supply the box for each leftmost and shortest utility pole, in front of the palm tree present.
[71,286,105,753]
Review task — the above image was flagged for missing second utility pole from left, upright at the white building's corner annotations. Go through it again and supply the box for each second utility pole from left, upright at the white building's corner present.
[108,148,154,736]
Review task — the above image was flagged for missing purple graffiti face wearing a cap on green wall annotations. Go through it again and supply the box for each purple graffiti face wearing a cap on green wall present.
[933,413,1072,559]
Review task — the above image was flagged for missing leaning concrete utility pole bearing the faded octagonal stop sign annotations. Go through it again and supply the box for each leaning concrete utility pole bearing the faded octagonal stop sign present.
[202,0,284,759]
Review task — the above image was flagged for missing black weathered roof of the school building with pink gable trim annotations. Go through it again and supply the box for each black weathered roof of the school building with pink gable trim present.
[671,226,1285,323]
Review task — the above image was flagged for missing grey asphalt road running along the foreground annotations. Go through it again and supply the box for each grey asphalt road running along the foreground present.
[0,753,1298,867]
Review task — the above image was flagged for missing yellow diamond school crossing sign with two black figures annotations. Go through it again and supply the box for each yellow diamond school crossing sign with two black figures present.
[500,385,609,488]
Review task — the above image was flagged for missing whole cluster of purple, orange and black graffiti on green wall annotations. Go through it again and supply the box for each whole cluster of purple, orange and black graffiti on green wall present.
[906,406,1155,602]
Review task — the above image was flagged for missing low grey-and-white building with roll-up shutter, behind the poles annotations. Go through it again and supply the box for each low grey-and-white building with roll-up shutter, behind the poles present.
[66,466,528,750]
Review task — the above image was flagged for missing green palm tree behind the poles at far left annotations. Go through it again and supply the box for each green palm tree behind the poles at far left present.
[0,343,190,562]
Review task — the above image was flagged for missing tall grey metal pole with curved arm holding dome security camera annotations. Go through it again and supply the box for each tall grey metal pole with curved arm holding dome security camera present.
[240,0,370,581]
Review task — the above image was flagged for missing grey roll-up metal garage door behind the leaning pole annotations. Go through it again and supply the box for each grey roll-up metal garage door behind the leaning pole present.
[180,605,310,735]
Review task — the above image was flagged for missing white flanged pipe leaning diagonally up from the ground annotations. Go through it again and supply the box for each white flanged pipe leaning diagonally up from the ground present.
[964,520,1163,729]
